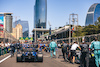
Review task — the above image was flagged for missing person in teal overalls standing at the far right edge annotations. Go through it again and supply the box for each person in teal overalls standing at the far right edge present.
[90,38,100,67]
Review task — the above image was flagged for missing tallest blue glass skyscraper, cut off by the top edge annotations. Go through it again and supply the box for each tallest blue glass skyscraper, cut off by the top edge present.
[34,0,47,28]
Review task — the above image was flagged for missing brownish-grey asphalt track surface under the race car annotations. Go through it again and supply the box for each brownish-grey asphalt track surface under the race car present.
[0,52,79,67]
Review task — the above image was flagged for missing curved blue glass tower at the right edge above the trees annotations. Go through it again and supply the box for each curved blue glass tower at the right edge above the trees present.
[85,3,100,26]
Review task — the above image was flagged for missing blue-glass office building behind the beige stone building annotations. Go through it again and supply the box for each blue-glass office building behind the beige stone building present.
[13,20,29,37]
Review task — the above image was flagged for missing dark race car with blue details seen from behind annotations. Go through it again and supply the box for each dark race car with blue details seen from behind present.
[16,47,43,62]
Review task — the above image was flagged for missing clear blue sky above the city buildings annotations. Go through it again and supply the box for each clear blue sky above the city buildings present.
[0,0,100,34]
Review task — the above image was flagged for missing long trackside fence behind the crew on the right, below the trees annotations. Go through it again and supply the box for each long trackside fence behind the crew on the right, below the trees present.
[55,34,100,44]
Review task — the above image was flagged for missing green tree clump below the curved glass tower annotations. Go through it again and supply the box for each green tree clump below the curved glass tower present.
[73,24,100,37]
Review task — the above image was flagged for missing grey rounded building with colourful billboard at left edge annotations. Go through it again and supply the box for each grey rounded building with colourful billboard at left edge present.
[0,13,12,33]
